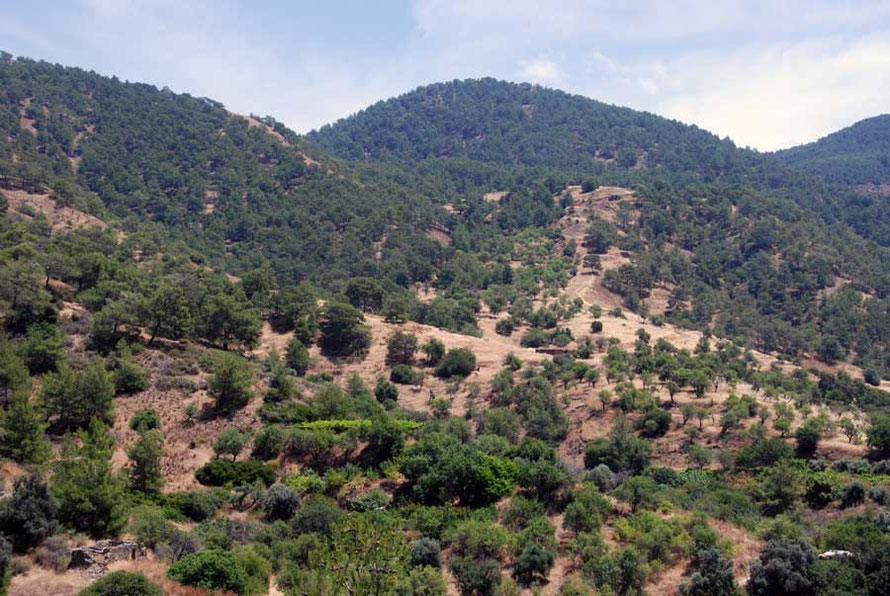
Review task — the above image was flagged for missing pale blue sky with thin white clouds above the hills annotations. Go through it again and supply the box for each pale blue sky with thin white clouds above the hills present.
[0,0,890,151]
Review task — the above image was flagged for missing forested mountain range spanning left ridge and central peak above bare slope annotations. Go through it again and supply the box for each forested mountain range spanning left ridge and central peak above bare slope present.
[0,59,890,371]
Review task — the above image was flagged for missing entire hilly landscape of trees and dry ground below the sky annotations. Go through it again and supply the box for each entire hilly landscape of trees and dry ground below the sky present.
[0,53,890,596]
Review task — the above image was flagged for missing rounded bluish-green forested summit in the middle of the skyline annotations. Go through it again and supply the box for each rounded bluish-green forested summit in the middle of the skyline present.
[309,79,756,174]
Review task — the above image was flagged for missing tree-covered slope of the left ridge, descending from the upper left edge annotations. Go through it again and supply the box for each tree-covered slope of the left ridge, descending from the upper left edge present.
[0,56,442,284]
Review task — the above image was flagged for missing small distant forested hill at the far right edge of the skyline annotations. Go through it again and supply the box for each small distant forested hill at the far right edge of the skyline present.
[775,114,890,186]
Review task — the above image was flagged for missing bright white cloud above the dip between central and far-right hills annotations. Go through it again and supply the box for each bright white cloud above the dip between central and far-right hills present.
[657,37,890,150]
